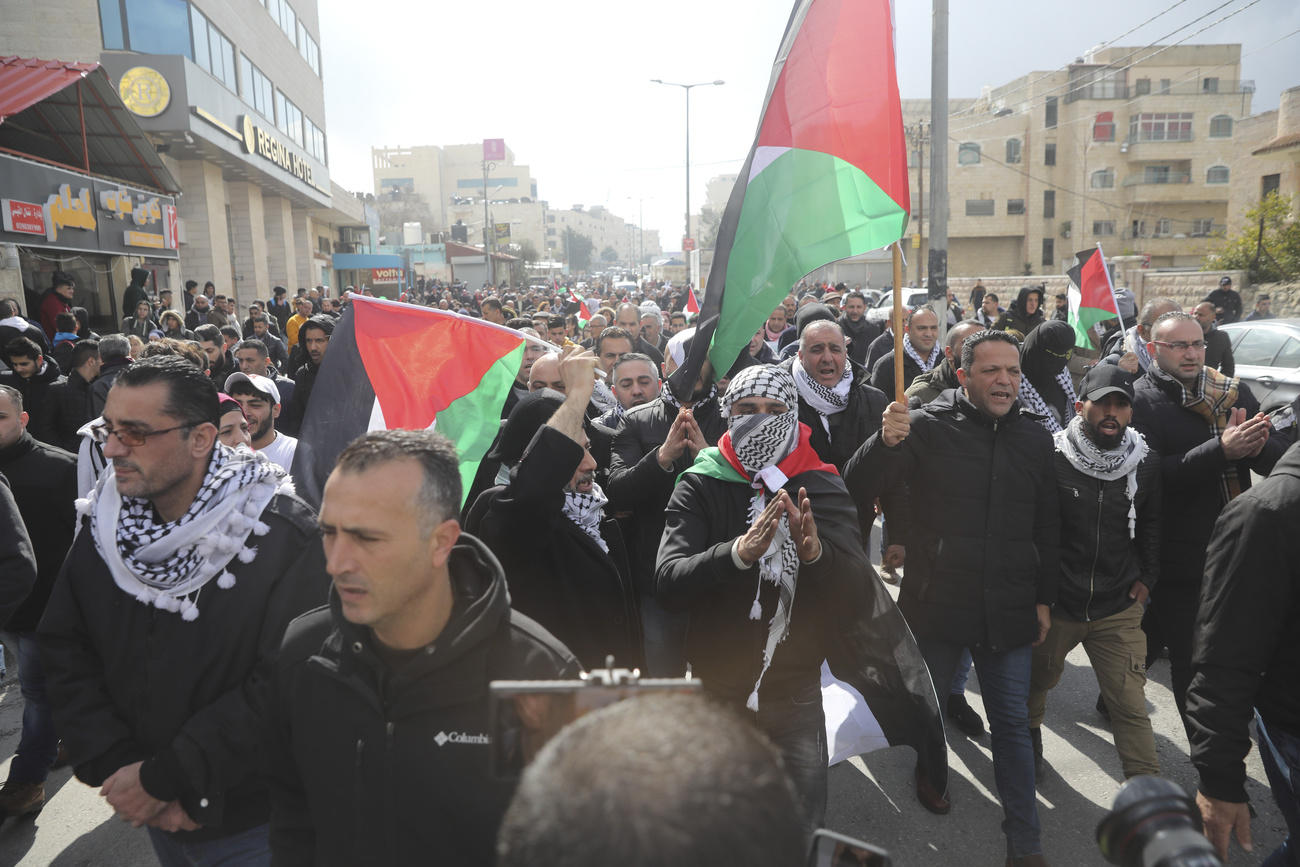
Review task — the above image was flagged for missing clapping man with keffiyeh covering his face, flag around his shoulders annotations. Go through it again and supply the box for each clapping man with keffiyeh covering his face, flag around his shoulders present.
[655,365,857,832]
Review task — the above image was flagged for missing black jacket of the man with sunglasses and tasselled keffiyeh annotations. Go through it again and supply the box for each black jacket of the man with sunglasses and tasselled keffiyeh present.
[38,494,329,840]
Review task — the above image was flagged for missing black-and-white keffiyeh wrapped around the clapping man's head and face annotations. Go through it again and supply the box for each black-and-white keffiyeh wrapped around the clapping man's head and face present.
[723,365,800,712]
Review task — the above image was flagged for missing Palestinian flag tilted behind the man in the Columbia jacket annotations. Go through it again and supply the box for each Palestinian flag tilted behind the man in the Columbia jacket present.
[293,295,525,507]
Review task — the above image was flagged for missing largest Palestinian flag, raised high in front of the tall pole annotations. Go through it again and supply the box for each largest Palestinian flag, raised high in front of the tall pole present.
[673,0,911,393]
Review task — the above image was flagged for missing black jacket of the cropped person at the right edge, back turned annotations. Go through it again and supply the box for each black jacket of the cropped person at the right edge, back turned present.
[1187,446,1300,802]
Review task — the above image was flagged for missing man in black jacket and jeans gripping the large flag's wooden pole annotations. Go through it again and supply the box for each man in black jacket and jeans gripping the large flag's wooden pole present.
[845,331,1061,867]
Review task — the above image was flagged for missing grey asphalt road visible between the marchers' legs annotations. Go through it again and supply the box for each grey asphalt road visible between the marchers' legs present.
[0,571,1286,867]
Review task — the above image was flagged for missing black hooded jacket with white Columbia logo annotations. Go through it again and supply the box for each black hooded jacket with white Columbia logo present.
[268,534,579,867]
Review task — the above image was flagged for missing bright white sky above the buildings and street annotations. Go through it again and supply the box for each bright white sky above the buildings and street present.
[319,0,1300,243]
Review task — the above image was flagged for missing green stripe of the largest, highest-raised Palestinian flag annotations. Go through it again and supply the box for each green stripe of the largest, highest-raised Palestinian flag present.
[709,148,907,376]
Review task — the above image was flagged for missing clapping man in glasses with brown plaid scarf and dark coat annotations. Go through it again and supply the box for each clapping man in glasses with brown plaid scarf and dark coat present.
[1132,312,1288,724]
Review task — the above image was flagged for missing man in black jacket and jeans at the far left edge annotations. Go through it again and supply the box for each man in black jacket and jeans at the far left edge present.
[0,386,77,819]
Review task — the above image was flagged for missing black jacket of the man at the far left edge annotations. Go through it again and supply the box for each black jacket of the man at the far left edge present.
[0,434,77,632]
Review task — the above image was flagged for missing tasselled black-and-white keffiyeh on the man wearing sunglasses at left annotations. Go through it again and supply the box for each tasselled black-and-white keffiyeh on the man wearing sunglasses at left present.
[77,443,293,620]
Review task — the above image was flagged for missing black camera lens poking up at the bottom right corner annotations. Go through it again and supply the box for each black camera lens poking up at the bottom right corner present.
[1097,776,1222,867]
